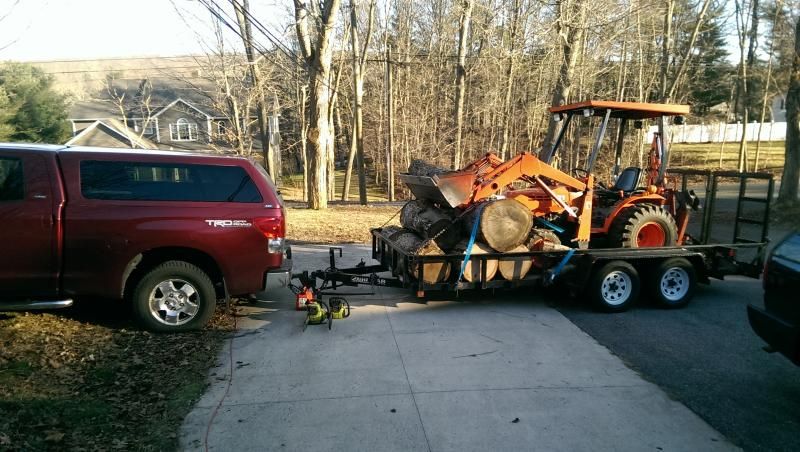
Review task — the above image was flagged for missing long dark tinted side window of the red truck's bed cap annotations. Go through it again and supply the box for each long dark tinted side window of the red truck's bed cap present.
[81,160,263,203]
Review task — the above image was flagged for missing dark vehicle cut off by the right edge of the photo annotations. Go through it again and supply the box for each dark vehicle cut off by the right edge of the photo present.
[747,231,800,365]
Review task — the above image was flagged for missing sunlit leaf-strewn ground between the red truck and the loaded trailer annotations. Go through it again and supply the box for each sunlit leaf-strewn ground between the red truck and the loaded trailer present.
[286,205,400,243]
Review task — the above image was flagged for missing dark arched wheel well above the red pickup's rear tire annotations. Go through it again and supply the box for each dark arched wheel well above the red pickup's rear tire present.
[122,247,226,299]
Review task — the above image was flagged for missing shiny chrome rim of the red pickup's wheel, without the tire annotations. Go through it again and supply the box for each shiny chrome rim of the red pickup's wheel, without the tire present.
[150,279,200,326]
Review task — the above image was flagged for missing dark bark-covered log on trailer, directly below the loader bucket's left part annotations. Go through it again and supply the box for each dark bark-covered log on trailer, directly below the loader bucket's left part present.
[400,199,461,251]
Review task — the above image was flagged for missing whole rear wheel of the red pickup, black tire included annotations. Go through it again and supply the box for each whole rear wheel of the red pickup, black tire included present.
[132,261,217,333]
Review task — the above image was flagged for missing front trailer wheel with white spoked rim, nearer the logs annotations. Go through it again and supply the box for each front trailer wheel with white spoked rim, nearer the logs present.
[589,261,640,312]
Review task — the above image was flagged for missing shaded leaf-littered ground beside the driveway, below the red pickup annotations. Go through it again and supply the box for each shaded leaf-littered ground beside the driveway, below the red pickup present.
[0,301,233,451]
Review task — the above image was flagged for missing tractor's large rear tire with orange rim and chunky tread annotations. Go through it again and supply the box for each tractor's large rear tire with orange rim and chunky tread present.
[608,204,678,248]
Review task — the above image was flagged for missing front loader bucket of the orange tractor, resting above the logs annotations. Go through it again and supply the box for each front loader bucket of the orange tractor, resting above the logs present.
[399,171,477,207]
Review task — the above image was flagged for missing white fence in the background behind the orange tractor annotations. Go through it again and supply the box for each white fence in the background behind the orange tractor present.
[647,122,786,143]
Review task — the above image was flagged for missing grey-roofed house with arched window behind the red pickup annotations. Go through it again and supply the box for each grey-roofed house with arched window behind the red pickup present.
[68,78,260,152]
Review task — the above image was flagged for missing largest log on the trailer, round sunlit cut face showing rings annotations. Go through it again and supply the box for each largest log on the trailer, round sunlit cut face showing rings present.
[464,199,533,253]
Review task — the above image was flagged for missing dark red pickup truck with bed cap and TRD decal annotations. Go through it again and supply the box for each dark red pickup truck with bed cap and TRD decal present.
[0,144,291,331]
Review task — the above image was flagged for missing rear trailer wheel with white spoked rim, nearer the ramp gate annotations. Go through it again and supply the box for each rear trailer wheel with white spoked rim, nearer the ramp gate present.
[649,257,697,309]
